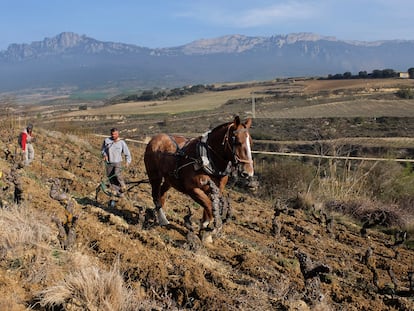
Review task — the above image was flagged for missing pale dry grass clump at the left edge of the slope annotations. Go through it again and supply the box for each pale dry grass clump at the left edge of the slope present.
[0,205,64,310]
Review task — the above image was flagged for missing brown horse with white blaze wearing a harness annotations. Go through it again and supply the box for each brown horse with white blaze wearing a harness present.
[144,116,254,229]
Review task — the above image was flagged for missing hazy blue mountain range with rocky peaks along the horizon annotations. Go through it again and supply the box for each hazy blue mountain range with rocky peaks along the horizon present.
[0,32,414,92]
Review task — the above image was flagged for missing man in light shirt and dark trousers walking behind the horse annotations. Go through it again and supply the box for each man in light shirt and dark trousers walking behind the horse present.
[101,128,132,195]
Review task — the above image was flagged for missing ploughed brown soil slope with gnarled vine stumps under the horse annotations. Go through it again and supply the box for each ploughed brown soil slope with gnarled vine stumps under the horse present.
[0,128,414,310]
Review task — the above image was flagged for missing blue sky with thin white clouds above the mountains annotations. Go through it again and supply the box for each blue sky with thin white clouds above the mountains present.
[0,0,414,50]
